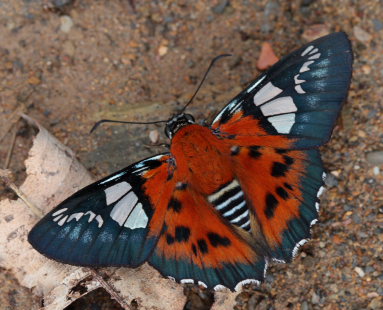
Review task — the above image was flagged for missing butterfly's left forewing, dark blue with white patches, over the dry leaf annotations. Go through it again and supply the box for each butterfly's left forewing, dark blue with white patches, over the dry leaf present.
[28,155,173,266]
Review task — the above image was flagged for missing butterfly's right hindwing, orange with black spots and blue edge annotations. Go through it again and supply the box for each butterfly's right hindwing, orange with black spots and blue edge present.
[231,147,324,261]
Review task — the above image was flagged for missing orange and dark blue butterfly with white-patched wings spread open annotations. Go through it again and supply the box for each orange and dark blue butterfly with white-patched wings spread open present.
[28,32,353,290]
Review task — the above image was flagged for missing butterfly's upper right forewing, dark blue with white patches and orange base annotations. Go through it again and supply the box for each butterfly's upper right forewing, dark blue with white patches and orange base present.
[212,32,352,149]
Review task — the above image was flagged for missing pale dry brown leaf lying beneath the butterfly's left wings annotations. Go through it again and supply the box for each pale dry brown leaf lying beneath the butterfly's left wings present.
[0,116,185,310]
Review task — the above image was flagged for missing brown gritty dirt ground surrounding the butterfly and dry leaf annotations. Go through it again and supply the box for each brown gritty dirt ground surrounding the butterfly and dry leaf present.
[0,0,383,309]
